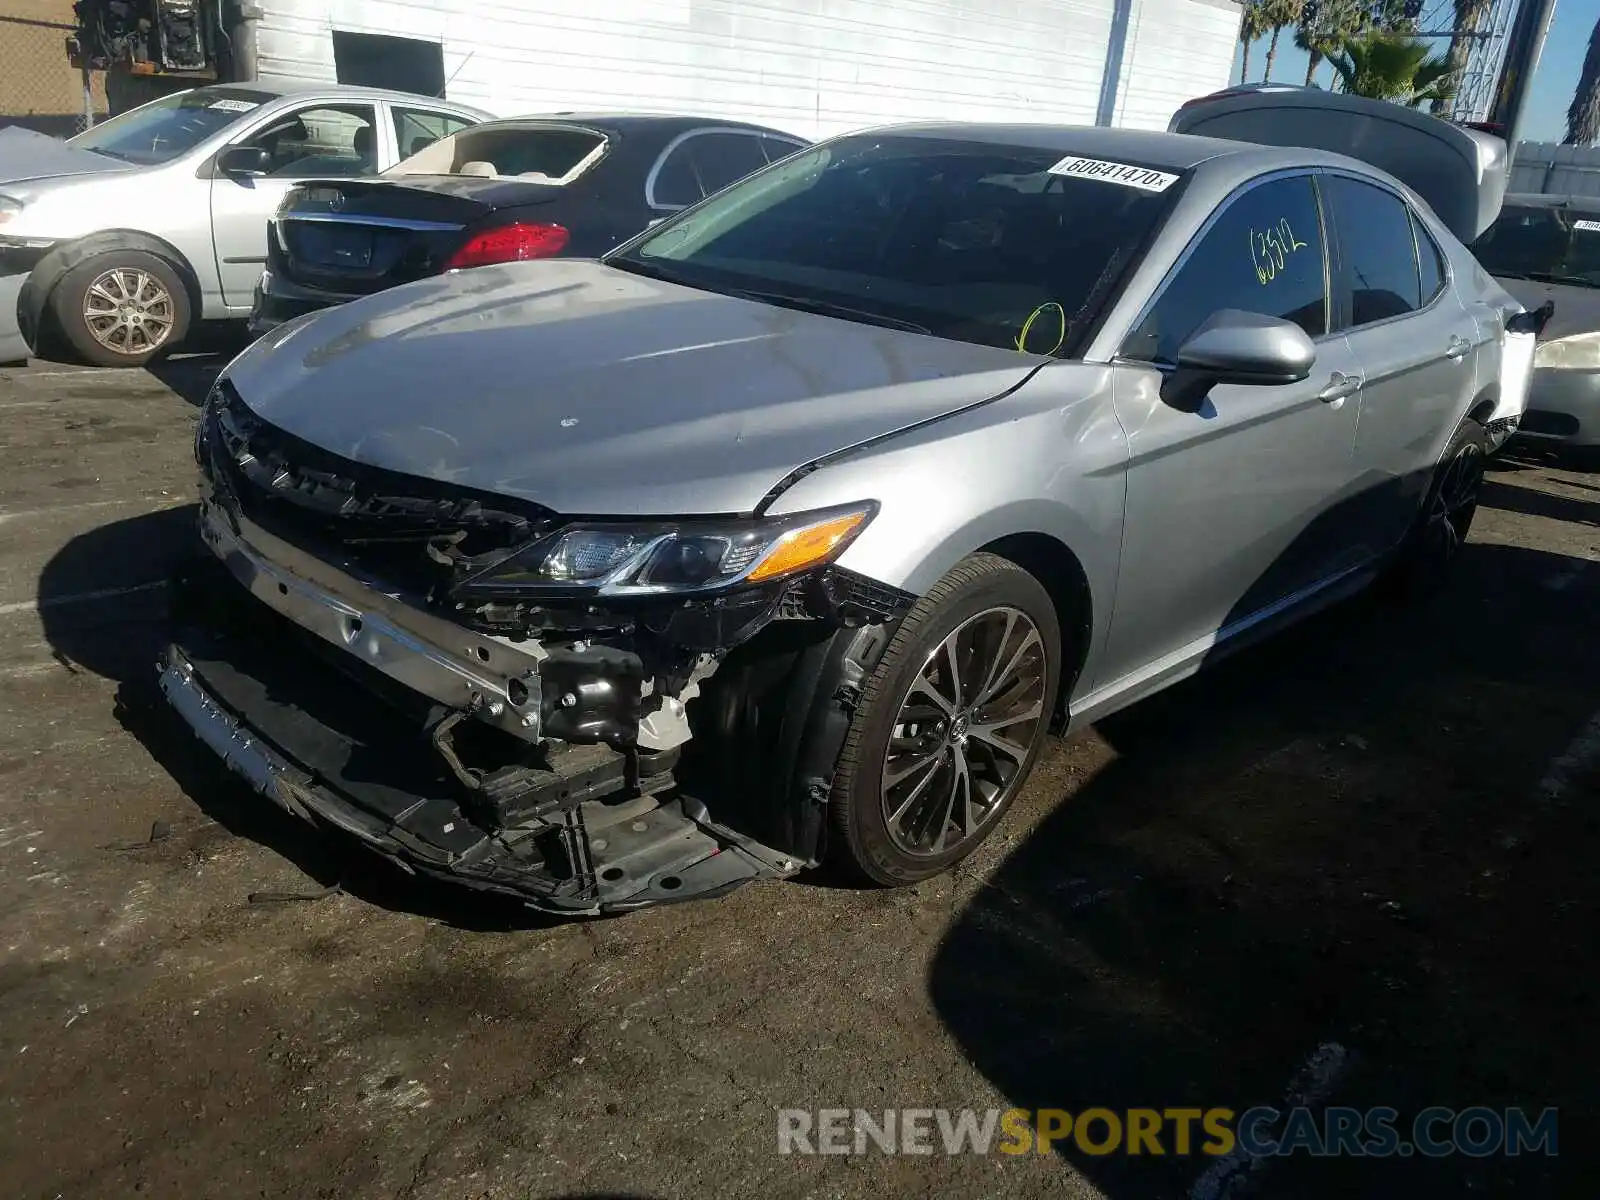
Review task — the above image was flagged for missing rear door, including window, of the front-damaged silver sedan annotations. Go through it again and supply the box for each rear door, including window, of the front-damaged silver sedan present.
[1323,173,1483,555]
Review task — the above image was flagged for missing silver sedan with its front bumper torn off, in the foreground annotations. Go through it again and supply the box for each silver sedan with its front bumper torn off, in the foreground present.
[160,126,1520,912]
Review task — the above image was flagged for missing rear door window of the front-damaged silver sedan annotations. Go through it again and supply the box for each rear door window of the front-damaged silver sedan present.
[1325,176,1422,328]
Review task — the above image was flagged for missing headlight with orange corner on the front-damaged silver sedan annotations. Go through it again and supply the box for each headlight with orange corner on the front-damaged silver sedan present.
[454,501,877,598]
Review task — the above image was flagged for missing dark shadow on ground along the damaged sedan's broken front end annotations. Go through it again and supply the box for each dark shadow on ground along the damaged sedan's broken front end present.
[38,504,552,931]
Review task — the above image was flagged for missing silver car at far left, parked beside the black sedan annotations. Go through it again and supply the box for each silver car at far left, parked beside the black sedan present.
[0,83,490,366]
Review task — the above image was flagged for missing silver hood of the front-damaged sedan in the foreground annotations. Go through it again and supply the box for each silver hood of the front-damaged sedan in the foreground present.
[227,259,1050,515]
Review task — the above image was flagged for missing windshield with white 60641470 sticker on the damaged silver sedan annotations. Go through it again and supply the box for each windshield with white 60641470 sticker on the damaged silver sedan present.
[606,134,1179,355]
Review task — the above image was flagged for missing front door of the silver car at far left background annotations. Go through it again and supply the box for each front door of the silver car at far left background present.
[211,104,379,309]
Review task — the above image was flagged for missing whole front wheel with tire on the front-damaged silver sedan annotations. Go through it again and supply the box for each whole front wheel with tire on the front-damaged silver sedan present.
[829,554,1061,886]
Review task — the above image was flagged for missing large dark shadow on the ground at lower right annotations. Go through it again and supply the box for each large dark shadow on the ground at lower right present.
[930,544,1600,1200]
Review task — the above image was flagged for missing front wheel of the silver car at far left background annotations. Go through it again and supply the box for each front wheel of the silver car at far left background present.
[50,250,189,366]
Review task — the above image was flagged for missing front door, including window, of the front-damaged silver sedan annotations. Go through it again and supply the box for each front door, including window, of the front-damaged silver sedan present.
[1098,174,1362,685]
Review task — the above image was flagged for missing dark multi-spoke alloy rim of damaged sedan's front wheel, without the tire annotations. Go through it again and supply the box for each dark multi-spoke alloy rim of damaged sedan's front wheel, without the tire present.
[880,606,1048,858]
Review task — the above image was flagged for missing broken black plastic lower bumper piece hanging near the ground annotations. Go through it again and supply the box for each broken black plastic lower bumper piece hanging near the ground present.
[160,579,803,915]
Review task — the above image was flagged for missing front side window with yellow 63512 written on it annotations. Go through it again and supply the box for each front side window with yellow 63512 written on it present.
[1123,176,1328,363]
